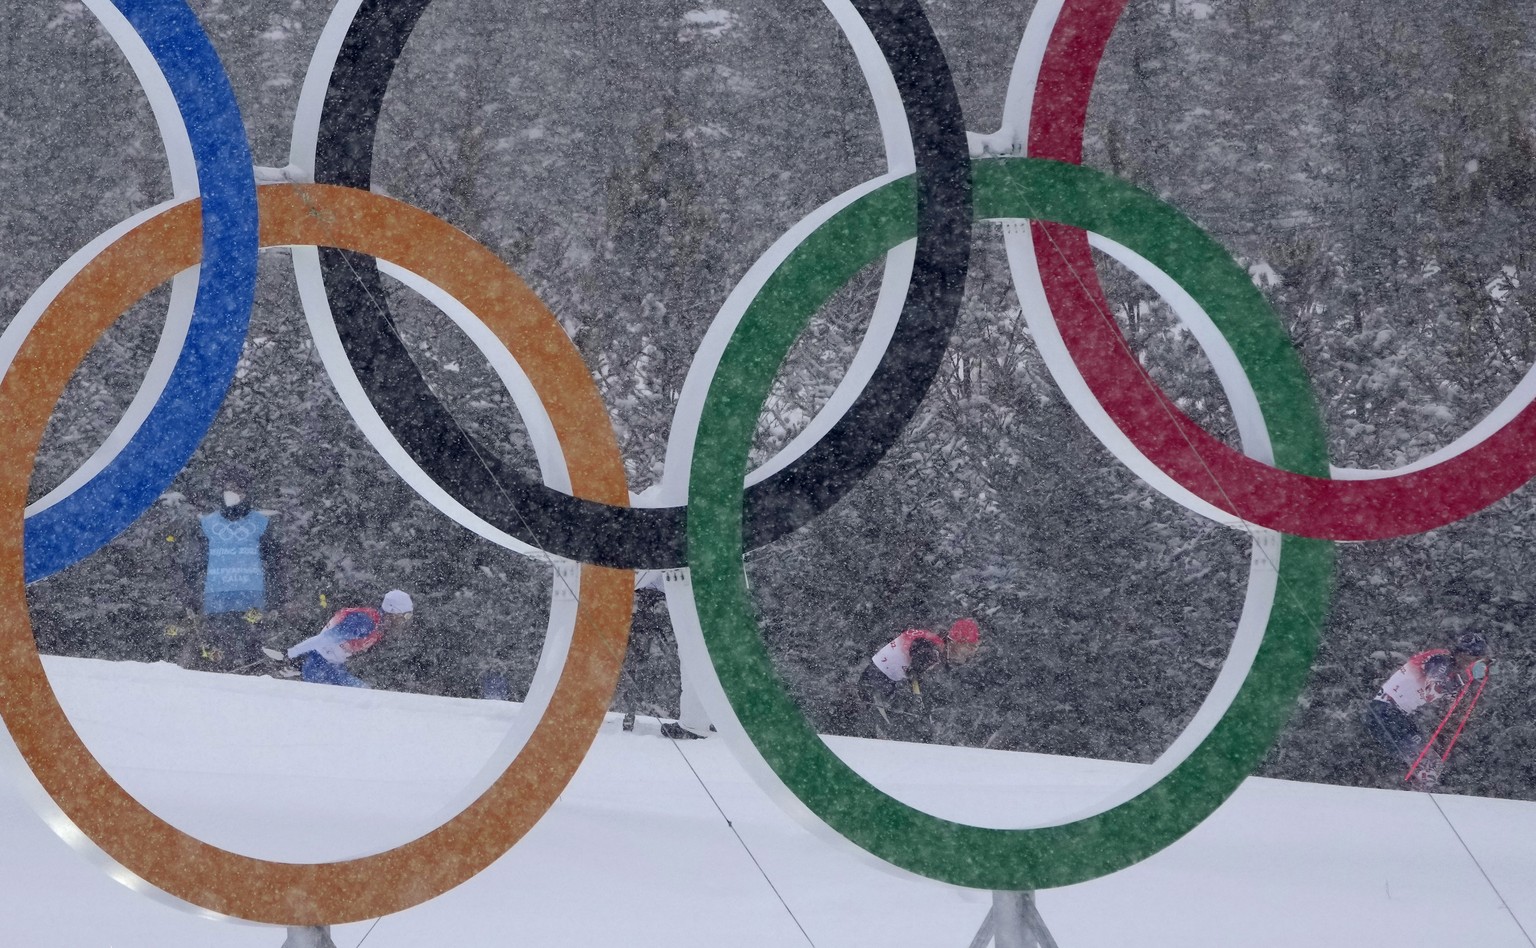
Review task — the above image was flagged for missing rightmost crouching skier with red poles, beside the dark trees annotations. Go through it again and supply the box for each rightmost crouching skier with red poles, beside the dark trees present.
[1366,631,1488,790]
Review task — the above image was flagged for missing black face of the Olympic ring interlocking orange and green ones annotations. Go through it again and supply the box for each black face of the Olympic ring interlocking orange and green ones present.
[315,0,972,568]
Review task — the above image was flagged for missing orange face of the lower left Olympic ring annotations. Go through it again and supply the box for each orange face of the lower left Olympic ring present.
[0,184,634,925]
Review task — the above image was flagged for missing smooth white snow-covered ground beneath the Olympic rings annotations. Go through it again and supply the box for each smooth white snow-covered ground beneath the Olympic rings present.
[0,659,1536,948]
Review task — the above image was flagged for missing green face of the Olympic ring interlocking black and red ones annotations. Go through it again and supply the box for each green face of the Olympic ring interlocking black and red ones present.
[688,158,1333,891]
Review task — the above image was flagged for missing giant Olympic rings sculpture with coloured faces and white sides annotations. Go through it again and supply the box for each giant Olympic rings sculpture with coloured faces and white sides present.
[0,0,1536,925]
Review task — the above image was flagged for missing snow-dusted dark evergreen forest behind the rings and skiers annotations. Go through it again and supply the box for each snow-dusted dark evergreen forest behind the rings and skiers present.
[0,0,1536,799]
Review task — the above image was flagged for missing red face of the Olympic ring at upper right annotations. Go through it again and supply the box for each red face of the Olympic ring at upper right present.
[1026,0,1536,541]
